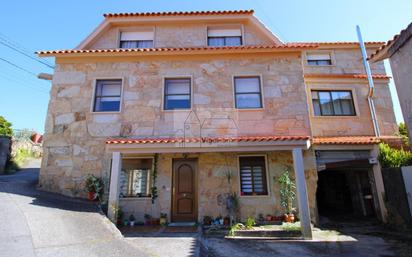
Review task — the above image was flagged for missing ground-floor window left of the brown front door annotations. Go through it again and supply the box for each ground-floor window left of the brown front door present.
[120,158,153,197]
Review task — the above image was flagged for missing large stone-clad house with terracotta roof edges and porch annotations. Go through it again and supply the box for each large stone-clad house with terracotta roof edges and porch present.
[38,11,397,237]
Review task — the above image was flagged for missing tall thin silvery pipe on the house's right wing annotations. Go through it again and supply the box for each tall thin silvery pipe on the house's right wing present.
[356,26,381,137]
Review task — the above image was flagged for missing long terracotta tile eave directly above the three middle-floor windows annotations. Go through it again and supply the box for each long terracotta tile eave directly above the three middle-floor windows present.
[36,43,317,55]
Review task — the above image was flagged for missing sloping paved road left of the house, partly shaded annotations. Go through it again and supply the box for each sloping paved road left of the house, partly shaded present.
[0,161,150,257]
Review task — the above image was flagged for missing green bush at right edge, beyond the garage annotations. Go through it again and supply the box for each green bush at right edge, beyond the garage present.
[378,143,412,168]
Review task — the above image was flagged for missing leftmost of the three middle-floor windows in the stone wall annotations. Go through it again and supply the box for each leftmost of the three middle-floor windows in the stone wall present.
[93,79,122,112]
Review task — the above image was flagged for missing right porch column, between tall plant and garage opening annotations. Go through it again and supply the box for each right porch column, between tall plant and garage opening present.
[292,148,312,239]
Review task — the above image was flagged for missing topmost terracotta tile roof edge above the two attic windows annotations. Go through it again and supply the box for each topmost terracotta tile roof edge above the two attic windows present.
[103,10,254,18]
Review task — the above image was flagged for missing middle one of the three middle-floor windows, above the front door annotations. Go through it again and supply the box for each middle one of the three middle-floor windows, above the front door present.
[164,78,191,110]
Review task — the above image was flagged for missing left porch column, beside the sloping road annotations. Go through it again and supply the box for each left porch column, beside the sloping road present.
[107,152,122,223]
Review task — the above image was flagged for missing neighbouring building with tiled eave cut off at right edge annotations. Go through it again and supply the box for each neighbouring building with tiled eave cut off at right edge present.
[369,23,412,145]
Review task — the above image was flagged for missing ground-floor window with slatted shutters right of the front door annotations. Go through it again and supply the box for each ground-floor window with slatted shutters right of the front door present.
[239,156,268,195]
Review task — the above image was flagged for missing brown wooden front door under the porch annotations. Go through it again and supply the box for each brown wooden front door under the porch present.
[172,159,197,221]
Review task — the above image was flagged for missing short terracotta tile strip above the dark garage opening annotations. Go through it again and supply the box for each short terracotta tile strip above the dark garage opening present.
[311,136,399,145]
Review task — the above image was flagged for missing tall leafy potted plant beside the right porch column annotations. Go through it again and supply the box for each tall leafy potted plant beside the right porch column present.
[278,170,296,213]
